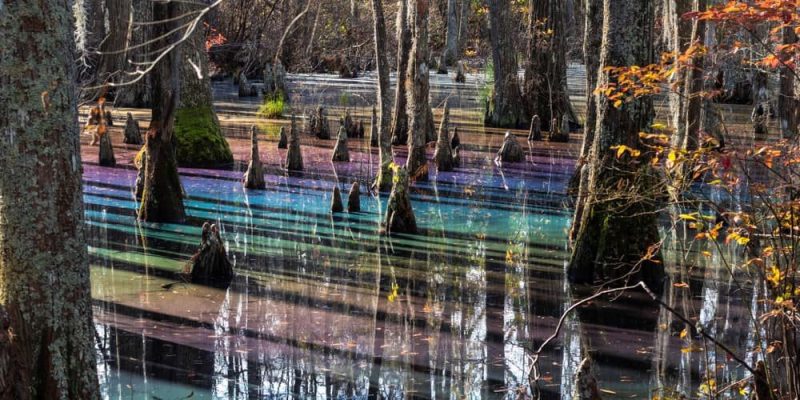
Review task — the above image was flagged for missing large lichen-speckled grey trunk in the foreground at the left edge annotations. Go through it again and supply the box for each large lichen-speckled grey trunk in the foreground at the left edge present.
[0,0,100,400]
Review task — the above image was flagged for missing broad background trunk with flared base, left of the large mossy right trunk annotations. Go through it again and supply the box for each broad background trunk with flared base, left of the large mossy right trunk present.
[525,0,576,131]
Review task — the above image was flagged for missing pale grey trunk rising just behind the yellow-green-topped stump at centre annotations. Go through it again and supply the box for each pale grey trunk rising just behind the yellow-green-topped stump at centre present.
[406,0,433,180]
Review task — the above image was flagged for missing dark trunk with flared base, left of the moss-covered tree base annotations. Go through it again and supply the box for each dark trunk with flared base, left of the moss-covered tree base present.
[139,2,186,222]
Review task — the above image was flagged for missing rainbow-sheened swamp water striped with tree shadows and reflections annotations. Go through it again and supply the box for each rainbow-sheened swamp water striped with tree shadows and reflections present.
[84,69,753,399]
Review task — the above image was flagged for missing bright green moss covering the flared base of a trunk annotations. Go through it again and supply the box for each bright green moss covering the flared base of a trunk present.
[175,107,233,167]
